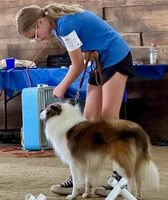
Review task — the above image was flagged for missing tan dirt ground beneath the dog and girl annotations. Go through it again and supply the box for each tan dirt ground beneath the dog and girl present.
[0,146,168,200]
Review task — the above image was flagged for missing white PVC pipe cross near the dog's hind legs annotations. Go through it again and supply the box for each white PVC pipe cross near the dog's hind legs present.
[105,177,137,200]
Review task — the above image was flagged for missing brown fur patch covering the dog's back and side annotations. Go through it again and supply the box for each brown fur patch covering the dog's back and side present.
[67,120,150,165]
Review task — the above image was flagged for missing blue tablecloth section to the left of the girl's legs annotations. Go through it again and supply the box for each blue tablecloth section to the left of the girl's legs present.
[0,68,88,98]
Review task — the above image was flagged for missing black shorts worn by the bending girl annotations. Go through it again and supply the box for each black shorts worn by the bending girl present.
[88,52,135,85]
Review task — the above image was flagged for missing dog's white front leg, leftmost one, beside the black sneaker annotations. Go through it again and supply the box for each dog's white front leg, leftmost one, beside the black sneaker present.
[66,163,80,200]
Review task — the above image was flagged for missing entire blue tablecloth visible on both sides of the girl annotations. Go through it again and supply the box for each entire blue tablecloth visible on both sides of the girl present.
[0,64,168,98]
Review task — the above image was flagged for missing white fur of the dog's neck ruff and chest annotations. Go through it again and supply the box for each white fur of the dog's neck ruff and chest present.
[41,103,84,164]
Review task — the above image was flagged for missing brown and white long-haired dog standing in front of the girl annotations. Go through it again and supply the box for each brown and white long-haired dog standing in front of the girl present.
[40,102,159,200]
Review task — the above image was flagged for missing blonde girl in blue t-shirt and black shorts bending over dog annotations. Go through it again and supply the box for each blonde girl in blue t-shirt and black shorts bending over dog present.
[16,3,134,196]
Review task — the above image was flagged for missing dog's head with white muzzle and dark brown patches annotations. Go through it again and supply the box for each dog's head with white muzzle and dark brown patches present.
[40,101,82,122]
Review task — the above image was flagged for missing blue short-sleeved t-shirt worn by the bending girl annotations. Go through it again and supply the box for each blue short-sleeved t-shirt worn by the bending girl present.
[52,11,130,68]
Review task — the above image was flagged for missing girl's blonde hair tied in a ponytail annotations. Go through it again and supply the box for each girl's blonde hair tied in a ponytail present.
[16,3,84,35]
